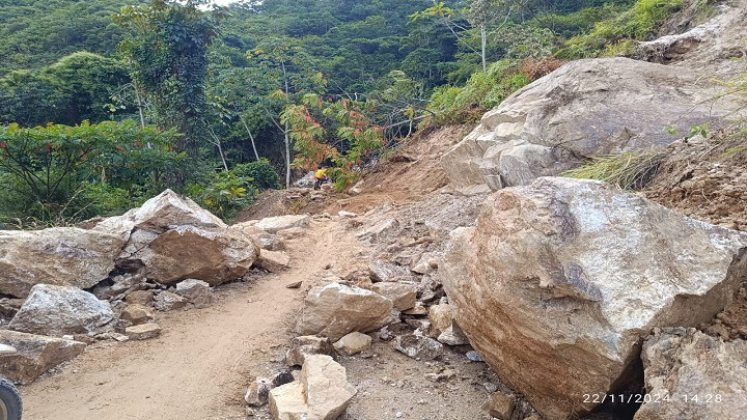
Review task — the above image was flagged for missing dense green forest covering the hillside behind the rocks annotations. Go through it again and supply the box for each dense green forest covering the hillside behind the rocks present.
[0,0,683,227]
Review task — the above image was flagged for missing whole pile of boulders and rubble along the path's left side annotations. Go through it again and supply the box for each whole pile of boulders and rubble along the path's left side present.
[0,190,308,383]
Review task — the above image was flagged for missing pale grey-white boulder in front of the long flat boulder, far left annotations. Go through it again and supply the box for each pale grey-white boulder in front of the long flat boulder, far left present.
[8,284,114,336]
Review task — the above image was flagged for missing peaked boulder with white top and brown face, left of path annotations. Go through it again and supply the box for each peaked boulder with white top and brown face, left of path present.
[103,190,259,286]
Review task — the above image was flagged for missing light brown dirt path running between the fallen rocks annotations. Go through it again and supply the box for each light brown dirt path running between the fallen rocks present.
[22,219,368,420]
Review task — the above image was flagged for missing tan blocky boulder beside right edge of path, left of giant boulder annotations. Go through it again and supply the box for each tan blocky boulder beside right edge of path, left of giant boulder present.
[297,283,392,341]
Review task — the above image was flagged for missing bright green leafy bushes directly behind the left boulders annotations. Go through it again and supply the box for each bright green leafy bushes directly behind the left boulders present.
[0,121,183,220]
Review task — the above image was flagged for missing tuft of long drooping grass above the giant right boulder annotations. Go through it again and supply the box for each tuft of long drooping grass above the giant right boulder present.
[562,150,666,190]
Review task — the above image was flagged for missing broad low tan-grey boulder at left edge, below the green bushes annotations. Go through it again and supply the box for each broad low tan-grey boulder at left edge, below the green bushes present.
[0,228,127,297]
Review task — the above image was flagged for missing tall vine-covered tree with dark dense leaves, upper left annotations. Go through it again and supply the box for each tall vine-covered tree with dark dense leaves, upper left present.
[115,0,221,156]
